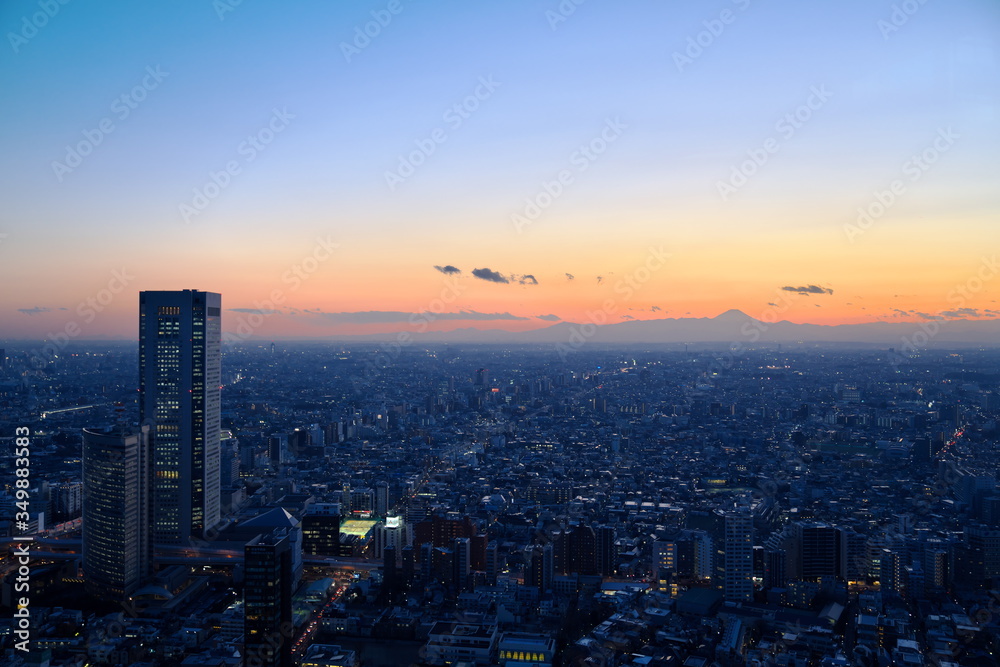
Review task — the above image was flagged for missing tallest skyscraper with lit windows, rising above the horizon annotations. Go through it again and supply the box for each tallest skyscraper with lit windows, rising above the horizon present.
[139,290,222,544]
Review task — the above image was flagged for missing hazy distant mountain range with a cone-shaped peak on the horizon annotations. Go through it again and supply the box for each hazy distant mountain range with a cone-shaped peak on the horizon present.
[320,310,1000,349]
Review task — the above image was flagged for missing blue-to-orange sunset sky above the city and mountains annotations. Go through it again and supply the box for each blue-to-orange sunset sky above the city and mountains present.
[0,0,1000,340]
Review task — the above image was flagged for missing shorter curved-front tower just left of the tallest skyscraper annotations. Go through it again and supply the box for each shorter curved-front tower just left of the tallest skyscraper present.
[83,426,152,600]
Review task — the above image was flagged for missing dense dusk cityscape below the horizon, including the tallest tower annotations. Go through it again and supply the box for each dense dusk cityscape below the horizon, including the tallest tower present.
[0,290,1000,667]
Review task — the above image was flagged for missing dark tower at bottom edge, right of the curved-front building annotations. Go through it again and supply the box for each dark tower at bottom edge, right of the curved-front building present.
[243,529,292,667]
